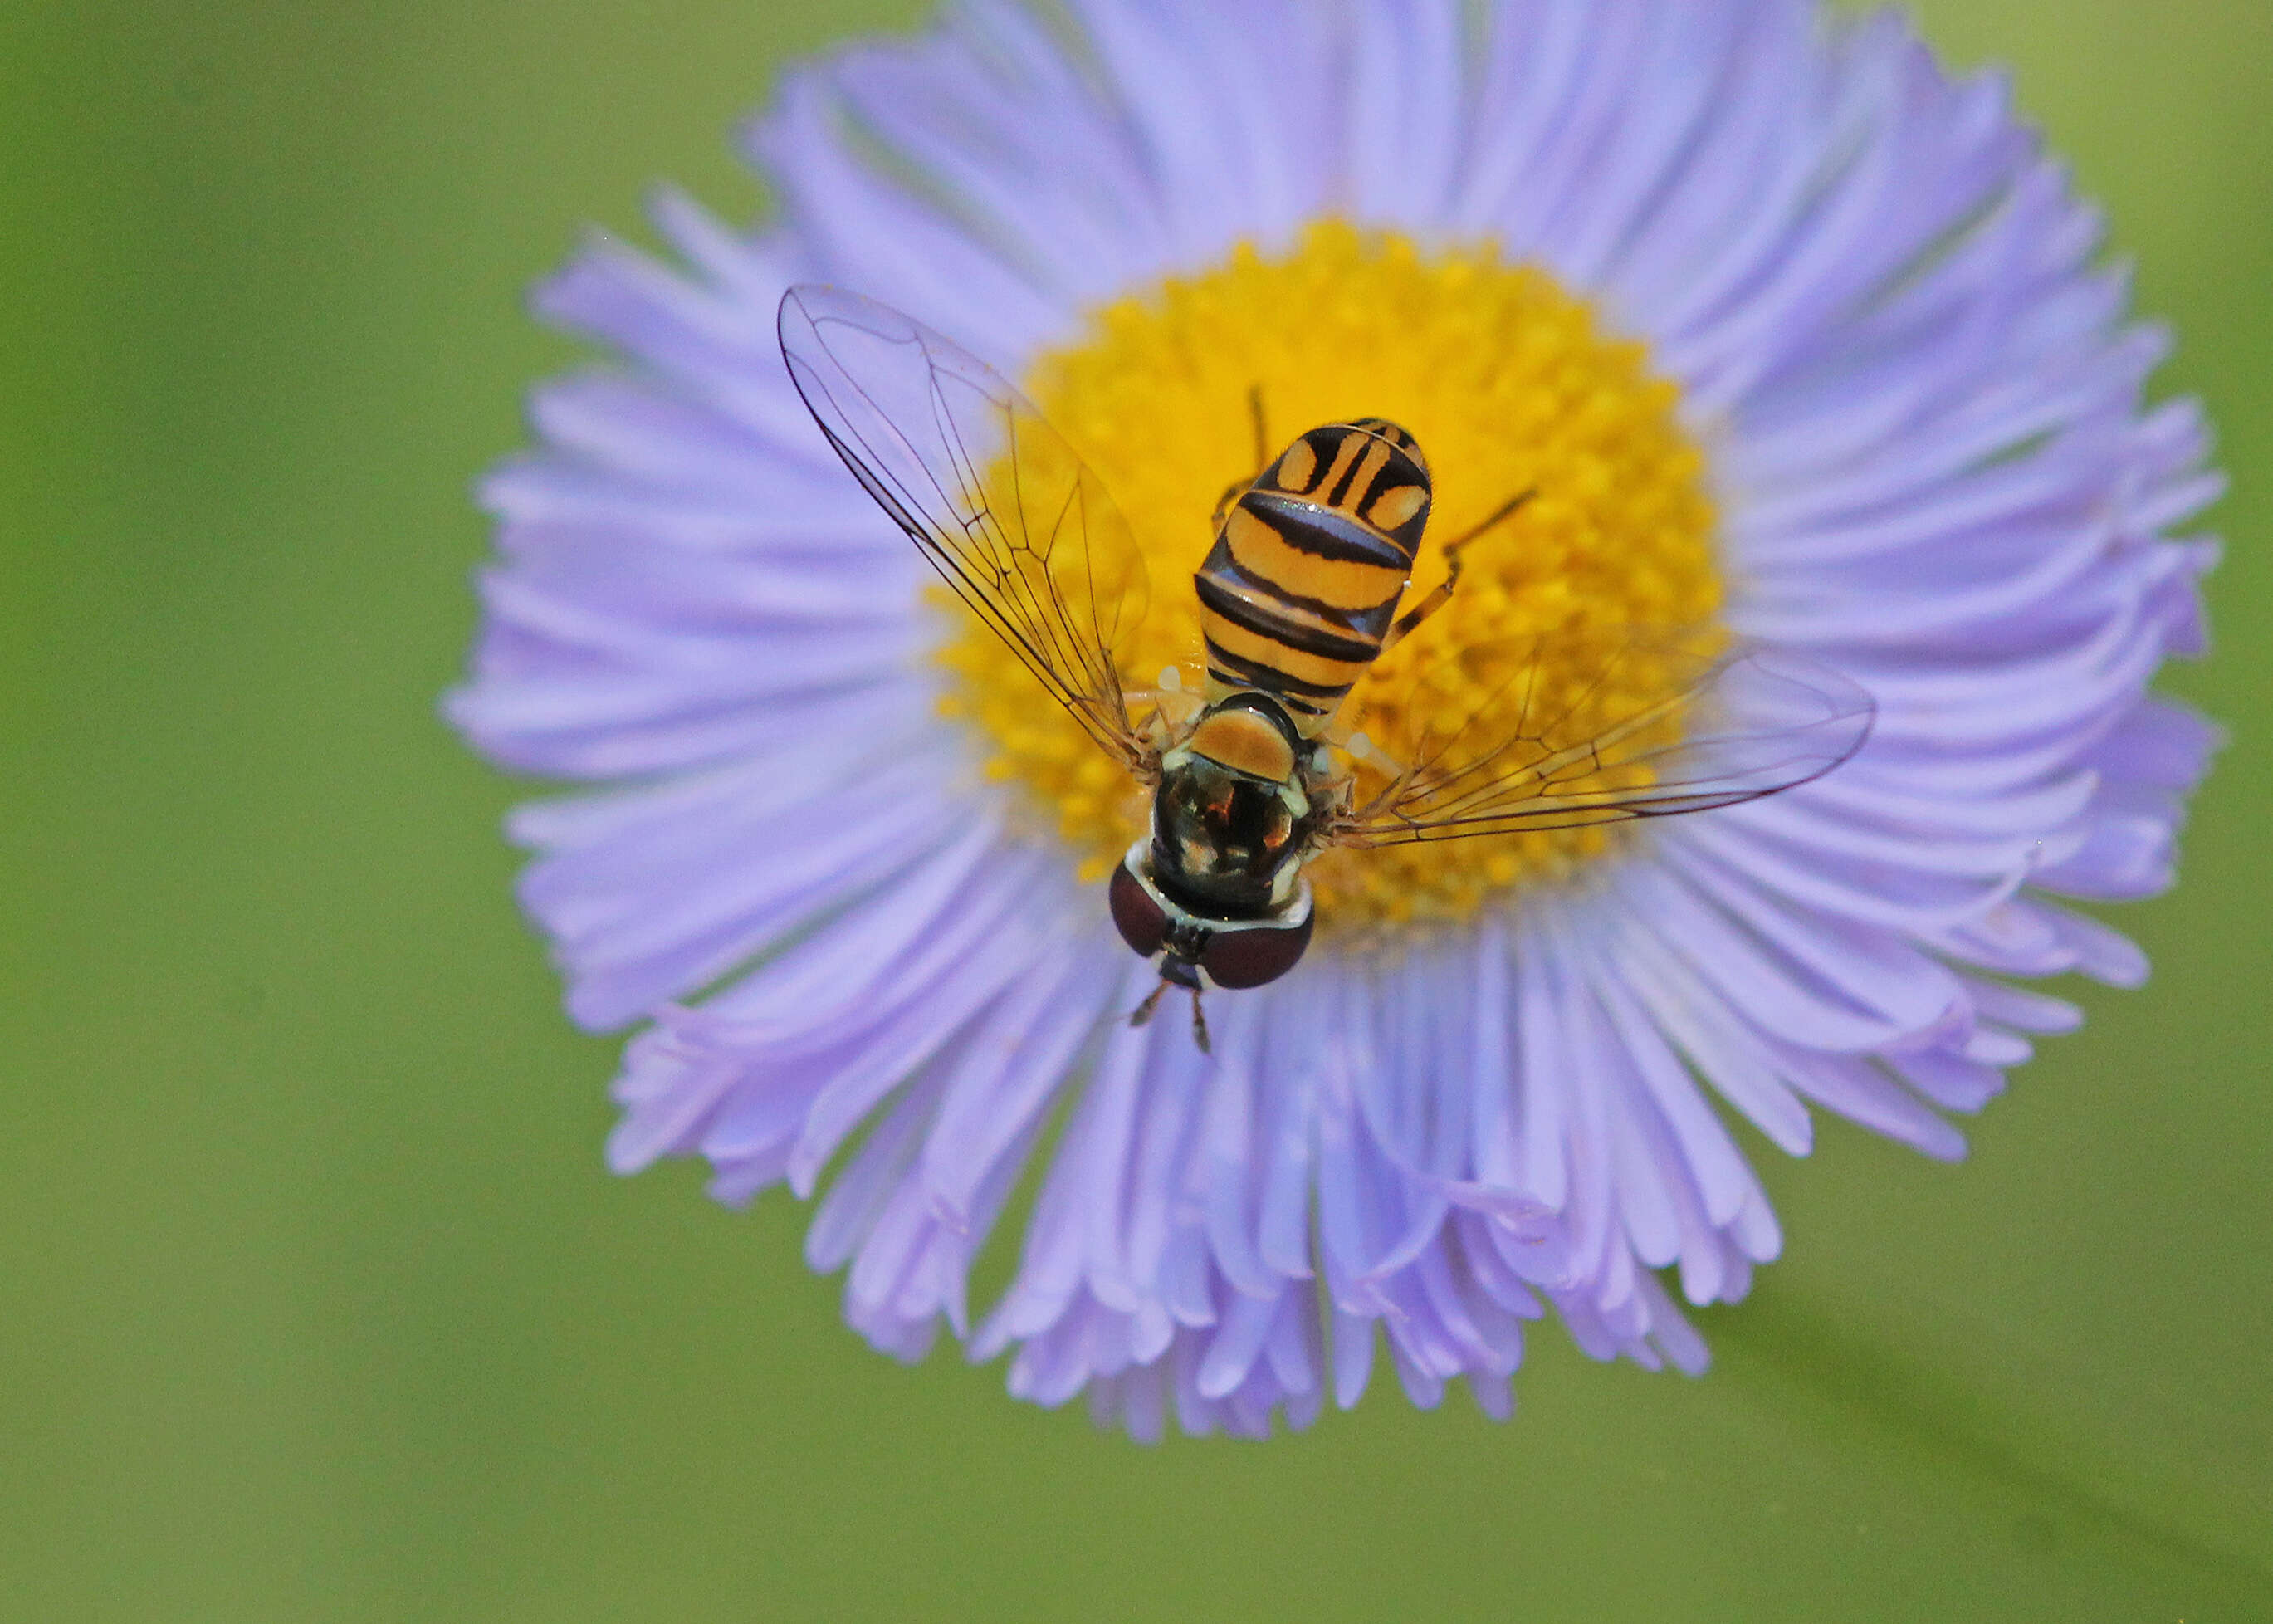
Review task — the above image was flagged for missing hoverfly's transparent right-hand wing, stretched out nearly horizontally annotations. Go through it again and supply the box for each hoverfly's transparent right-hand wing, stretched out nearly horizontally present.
[1327,633,1875,849]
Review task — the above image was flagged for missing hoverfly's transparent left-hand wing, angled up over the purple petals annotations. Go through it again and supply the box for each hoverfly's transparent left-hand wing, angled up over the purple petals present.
[780,284,1150,771]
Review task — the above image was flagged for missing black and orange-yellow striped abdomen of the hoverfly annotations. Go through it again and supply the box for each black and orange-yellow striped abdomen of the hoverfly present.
[1191,416,1430,737]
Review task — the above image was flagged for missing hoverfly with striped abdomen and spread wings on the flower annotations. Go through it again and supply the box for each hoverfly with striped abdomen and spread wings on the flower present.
[780,284,1873,1049]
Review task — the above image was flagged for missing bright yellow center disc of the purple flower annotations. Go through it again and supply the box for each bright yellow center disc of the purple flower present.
[939,223,1721,932]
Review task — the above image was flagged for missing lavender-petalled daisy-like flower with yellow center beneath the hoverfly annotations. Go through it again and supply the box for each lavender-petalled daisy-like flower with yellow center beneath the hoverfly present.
[450,0,2218,1437]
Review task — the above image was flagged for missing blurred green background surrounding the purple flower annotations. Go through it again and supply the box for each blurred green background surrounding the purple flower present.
[0,0,2273,1624]
